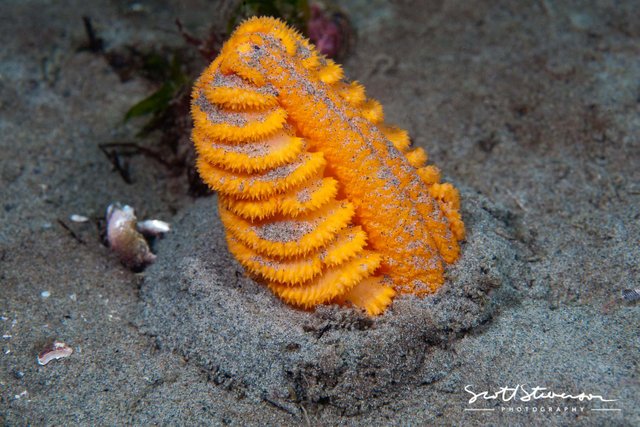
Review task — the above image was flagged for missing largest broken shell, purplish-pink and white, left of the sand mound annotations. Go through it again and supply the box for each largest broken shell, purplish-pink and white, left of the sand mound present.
[107,203,156,269]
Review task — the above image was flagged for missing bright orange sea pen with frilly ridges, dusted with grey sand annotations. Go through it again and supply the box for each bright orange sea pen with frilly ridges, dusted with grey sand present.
[192,18,464,315]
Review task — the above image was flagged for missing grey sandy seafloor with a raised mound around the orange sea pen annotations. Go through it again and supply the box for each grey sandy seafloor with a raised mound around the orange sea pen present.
[0,0,640,426]
